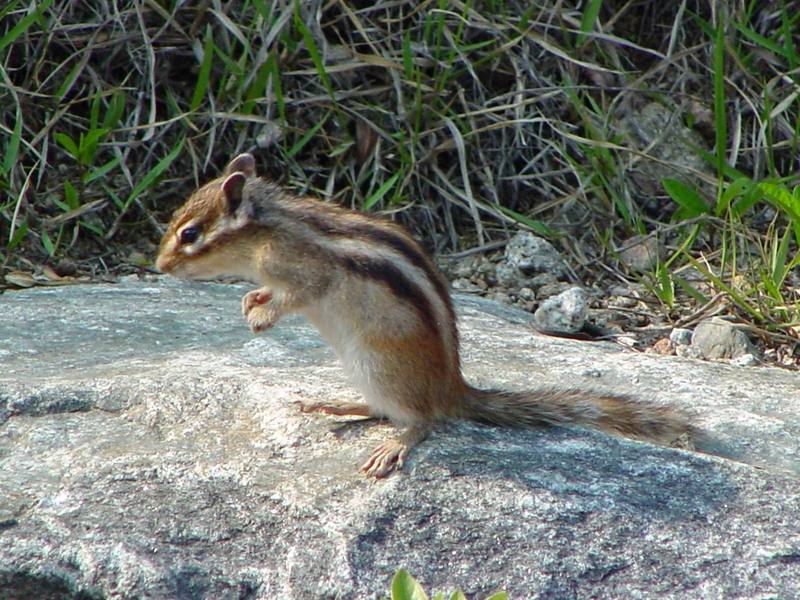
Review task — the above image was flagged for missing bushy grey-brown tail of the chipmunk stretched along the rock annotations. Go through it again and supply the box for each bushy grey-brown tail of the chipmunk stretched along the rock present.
[462,386,698,448]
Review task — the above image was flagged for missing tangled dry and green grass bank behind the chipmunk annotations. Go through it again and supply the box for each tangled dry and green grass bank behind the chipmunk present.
[0,0,800,354]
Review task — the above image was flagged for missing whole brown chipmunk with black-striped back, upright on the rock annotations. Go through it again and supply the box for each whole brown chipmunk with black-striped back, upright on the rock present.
[156,154,693,477]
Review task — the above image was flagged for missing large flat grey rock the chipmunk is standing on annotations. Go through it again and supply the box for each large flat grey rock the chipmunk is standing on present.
[0,280,800,600]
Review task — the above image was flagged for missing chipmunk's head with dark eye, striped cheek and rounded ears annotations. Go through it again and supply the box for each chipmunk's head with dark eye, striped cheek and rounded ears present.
[156,154,256,279]
